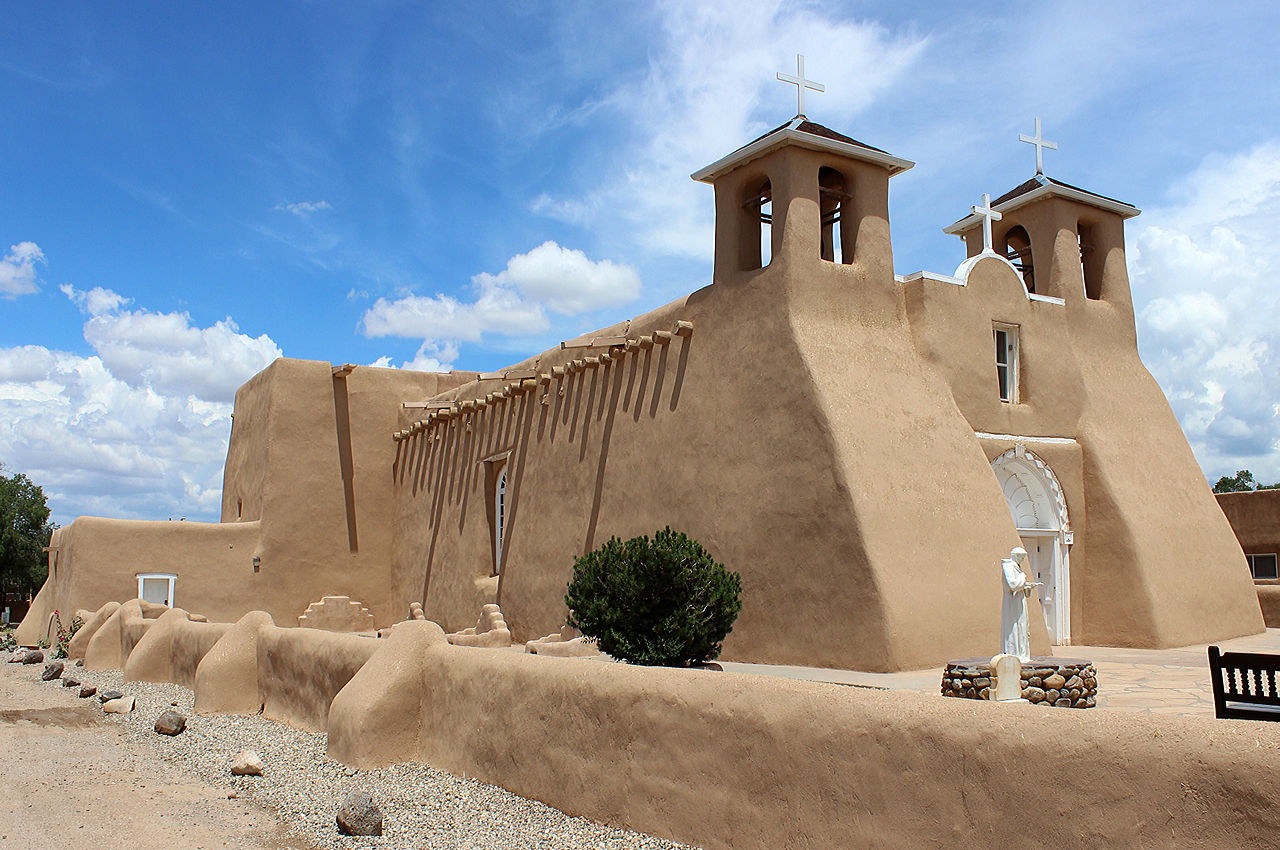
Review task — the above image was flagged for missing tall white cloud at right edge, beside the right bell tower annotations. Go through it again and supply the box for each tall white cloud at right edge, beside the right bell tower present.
[1129,142,1280,483]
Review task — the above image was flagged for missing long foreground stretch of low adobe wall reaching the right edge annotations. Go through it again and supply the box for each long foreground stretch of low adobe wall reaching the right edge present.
[329,622,1280,850]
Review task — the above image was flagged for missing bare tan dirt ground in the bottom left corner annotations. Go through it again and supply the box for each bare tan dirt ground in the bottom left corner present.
[0,663,305,850]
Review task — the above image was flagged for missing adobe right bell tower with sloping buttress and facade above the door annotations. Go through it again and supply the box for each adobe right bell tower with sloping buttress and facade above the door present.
[904,200,1263,646]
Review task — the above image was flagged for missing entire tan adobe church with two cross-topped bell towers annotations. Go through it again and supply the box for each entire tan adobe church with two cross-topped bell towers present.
[19,69,1263,671]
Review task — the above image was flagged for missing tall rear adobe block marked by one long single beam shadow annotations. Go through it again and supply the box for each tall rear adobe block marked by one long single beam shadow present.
[217,358,474,626]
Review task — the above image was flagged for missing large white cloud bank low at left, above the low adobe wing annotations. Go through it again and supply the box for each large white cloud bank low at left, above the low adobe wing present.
[0,275,280,522]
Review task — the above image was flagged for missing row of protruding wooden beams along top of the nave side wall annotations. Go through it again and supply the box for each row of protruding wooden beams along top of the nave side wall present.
[392,320,694,443]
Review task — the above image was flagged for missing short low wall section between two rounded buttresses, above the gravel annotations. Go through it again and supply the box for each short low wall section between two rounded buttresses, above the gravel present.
[257,625,381,732]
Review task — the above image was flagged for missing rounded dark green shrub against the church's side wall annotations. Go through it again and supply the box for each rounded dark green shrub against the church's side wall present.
[564,527,742,667]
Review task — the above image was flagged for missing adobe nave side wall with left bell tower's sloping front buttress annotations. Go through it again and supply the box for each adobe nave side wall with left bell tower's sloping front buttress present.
[393,152,1047,670]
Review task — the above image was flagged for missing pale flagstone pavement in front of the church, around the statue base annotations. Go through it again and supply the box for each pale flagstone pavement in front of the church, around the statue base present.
[721,629,1280,717]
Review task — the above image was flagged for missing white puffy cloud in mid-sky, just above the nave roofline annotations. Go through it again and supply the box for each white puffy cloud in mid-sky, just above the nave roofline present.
[361,242,640,365]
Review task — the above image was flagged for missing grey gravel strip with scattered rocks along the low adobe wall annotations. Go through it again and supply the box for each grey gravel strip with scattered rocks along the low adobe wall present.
[37,666,685,850]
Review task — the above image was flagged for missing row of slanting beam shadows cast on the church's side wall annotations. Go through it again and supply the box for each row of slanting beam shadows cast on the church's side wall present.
[392,334,694,599]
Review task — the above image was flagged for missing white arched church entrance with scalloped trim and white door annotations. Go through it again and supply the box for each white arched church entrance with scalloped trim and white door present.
[991,445,1073,645]
